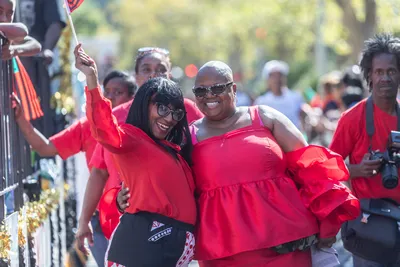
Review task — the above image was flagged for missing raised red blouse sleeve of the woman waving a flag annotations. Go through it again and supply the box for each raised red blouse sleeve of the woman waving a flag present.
[85,87,135,153]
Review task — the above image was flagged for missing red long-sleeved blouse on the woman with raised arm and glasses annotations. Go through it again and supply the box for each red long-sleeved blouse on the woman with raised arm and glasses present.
[86,88,196,224]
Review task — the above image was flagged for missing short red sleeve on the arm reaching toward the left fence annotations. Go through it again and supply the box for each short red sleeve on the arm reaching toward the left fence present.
[50,119,85,160]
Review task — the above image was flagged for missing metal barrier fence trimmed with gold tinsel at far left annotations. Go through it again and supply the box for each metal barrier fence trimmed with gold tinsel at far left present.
[0,36,70,267]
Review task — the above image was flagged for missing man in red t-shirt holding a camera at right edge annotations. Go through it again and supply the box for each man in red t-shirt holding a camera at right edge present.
[330,34,400,267]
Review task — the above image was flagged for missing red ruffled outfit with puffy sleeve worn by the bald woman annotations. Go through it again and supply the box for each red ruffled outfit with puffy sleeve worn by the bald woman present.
[192,107,360,267]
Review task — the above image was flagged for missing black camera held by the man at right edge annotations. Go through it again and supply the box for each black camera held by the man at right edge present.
[370,131,400,189]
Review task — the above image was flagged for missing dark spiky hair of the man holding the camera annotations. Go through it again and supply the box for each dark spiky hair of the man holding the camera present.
[360,33,400,90]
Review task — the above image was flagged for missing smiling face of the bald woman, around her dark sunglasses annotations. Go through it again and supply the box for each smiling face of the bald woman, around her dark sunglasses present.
[194,67,236,121]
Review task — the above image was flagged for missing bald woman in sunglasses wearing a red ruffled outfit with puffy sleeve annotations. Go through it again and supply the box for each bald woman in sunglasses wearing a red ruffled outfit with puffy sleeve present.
[191,62,360,267]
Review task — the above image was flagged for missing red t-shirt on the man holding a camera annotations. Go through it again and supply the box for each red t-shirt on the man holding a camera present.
[330,99,400,203]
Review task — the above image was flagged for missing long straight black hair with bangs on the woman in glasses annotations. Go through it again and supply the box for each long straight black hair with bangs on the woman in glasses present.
[126,77,193,165]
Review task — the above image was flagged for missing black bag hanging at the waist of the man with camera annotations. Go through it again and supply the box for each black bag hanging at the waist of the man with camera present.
[341,199,400,264]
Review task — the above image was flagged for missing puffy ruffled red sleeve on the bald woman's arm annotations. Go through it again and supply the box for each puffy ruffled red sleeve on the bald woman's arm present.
[286,145,360,238]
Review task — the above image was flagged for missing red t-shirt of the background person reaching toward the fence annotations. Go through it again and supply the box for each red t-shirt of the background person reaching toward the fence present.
[50,118,97,168]
